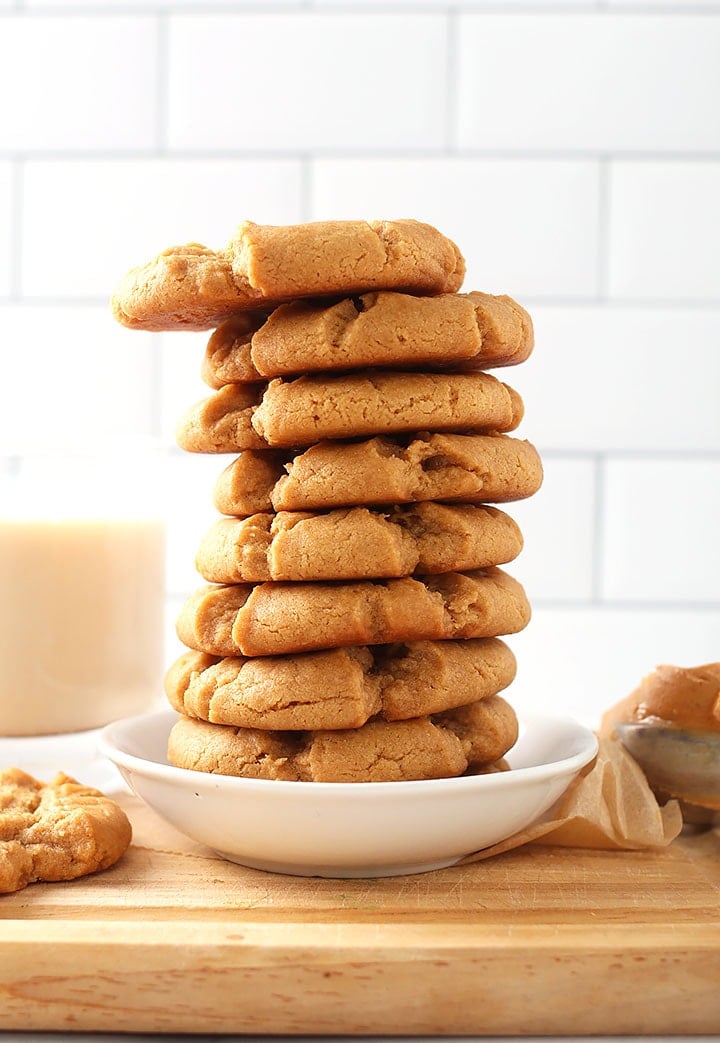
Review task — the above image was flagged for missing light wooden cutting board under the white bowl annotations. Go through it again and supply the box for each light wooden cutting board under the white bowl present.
[0,797,720,1035]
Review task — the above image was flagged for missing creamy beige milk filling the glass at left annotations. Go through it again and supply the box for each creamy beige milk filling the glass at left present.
[0,519,164,735]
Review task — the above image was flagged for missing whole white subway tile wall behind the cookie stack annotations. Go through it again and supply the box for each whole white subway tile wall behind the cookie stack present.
[0,0,720,723]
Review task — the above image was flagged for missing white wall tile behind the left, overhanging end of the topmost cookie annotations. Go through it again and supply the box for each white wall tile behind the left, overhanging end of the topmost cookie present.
[20,157,302,299]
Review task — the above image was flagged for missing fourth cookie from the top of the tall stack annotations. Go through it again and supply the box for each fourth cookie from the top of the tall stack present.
[213,433,543,516]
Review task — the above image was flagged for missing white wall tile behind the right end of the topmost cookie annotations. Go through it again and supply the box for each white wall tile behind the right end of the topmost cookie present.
[310,156,599,298]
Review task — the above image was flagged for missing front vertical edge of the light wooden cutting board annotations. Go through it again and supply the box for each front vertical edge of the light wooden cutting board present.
[0,931,720,1036]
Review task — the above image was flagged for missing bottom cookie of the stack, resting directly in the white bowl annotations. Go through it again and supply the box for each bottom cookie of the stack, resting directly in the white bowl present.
[168,696,518,782]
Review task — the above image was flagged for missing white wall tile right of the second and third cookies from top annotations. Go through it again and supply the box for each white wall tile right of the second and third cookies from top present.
[507,304,720,453]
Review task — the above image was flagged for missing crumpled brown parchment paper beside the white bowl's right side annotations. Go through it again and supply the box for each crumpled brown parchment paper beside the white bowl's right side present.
[462,738,682,864]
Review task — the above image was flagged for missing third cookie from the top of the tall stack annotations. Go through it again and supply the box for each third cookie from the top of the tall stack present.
[176,370,523,453]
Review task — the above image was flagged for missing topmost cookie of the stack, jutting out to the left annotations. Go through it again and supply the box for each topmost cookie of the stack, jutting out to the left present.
[111,220,465,330]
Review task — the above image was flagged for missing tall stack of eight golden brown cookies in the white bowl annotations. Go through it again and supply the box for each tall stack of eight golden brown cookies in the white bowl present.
[113,220,542,782]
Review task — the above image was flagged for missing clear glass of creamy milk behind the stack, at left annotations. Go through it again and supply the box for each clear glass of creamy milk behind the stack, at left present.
[0,447,165,738]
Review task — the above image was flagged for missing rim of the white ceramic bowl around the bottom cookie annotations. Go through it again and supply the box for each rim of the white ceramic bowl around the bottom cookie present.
[97,709,598,800]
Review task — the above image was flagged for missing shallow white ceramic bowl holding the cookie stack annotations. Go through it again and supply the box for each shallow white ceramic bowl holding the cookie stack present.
[99,710,597,877]
